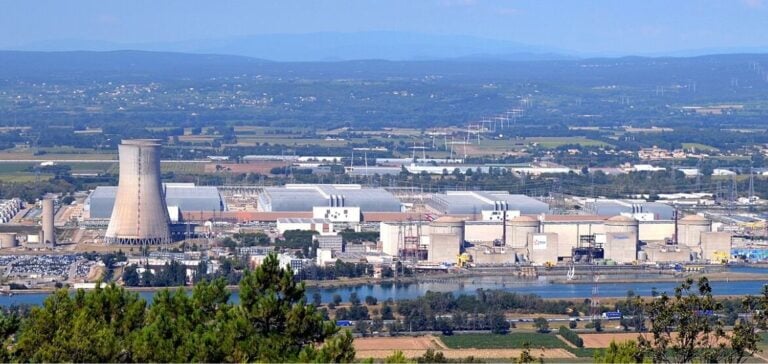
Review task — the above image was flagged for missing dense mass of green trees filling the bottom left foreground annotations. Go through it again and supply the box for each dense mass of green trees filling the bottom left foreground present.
[9,255,354,362]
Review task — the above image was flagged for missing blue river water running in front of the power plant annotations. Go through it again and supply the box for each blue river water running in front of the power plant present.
[0,267,768,306]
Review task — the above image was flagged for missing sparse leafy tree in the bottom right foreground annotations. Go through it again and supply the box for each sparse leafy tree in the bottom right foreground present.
[638,277,768,363]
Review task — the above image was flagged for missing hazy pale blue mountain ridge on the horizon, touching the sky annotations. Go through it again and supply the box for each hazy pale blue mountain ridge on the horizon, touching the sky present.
[10,32,574,62]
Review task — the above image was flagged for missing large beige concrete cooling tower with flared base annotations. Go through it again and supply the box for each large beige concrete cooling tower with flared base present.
[105,139,171,245]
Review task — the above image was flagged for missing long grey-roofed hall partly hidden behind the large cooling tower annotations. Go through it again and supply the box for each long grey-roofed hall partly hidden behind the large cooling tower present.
[84,183,226,219]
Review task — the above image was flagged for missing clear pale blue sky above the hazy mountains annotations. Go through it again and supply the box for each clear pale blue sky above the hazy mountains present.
[0,0,768,54]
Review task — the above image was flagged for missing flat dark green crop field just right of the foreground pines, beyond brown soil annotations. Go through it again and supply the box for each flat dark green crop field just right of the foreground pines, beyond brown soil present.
[440,332,570,349]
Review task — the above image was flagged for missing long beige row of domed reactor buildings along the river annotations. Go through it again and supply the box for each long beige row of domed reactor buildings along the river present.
[380,208,731,265]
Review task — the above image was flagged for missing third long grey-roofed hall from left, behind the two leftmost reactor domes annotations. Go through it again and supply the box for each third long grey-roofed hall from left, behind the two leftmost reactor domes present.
[427,191,549,215]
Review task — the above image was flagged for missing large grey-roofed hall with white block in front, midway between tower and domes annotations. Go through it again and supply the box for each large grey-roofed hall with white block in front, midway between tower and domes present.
[258,184,402,222]
